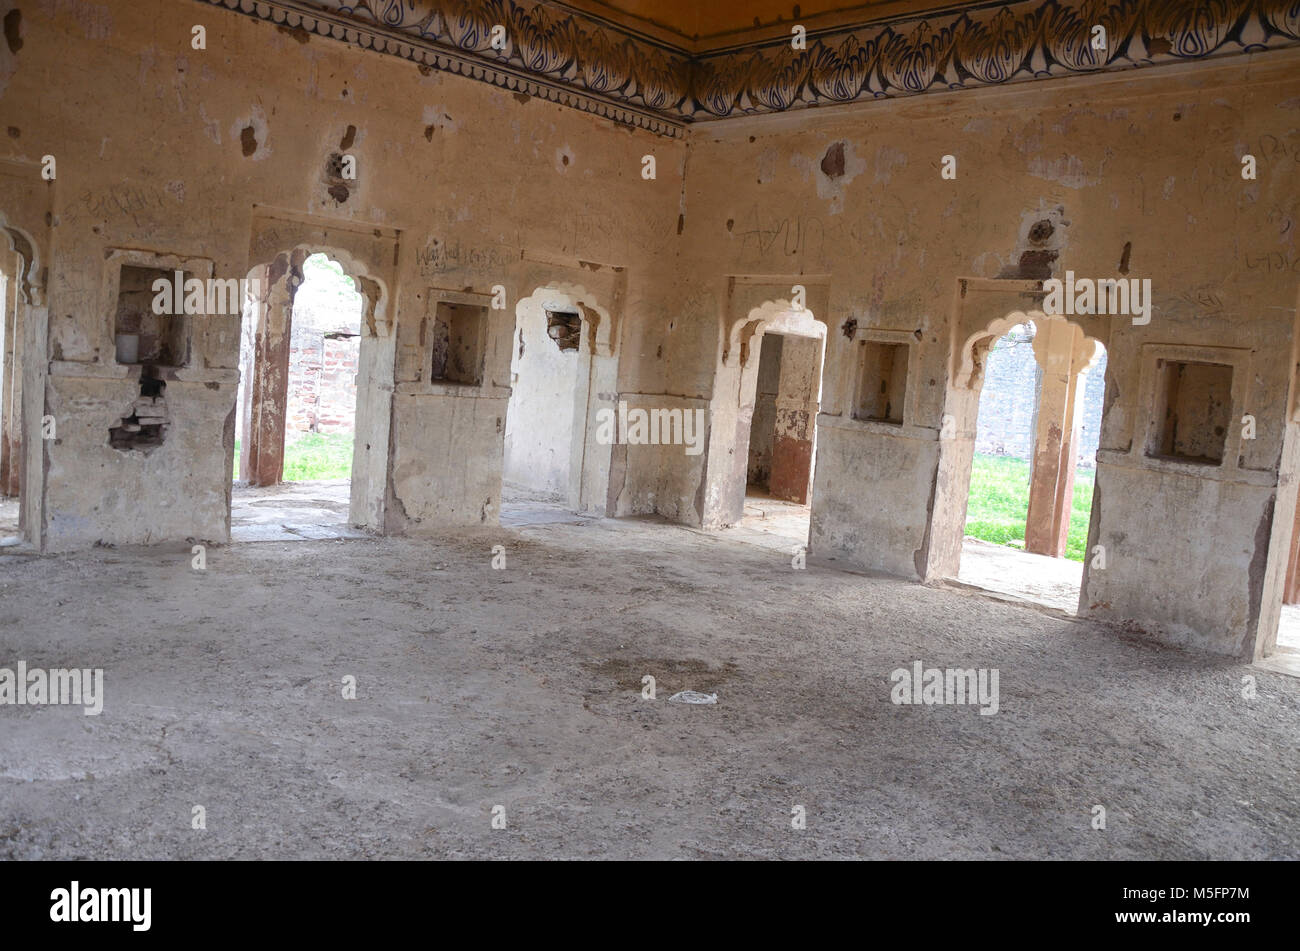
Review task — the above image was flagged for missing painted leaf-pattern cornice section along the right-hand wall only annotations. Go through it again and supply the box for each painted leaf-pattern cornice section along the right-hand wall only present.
[689,0,1300,121]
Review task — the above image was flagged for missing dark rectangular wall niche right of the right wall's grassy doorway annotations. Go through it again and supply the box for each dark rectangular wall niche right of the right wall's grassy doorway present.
[1147,360,1232,465]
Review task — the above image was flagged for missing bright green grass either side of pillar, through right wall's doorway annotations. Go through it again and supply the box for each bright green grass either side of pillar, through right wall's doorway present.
[966,452,1093,561]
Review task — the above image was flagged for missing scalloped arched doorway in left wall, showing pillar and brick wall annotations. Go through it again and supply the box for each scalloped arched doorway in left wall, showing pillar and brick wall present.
[231,246,393,540]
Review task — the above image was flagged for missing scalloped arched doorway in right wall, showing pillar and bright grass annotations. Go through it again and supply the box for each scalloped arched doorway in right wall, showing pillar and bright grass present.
[940,311,1105,613]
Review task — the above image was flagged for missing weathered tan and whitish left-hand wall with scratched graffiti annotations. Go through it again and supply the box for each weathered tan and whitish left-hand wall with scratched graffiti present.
[0,0,684,550]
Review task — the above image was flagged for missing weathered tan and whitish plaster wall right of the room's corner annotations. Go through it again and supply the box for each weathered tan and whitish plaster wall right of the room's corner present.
[671,53,1300,652]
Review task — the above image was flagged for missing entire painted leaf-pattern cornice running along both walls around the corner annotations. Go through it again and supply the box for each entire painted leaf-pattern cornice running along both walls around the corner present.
[200,0,1300,136]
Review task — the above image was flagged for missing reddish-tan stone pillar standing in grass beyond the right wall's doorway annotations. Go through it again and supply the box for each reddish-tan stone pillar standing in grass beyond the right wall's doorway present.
[1024,318,1100,557]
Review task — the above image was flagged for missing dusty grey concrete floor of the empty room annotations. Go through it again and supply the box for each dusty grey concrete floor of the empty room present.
[0,511,1300,859]
